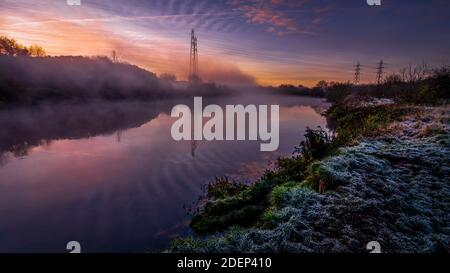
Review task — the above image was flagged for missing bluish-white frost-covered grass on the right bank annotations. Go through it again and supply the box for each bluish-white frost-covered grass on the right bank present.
[171,136,450,253]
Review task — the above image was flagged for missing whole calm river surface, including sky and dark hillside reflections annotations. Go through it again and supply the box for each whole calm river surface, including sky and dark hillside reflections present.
[0,94,328,252]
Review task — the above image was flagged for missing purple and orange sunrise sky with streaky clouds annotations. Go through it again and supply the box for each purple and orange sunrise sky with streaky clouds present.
[0,0,450,86]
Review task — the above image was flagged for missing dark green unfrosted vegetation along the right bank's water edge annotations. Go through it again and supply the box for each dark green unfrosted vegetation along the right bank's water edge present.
[190,128,337,234]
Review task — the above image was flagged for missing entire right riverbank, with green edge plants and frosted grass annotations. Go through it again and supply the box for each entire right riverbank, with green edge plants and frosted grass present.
[169,96,450,253]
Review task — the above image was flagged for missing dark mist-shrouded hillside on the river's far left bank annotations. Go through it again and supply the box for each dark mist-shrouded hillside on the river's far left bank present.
[0,56,232,105]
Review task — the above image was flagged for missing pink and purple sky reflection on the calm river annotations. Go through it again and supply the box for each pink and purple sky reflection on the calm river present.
[0,95,325,251]
